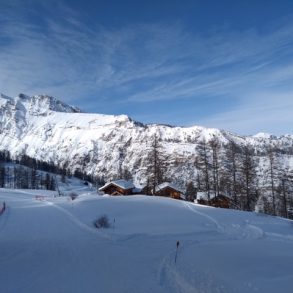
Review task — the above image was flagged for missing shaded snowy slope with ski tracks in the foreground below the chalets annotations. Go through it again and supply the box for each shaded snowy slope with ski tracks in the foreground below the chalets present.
[0,187,293,293]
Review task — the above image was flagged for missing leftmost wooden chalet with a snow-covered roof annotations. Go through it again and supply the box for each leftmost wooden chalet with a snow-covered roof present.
[99,179,136,195]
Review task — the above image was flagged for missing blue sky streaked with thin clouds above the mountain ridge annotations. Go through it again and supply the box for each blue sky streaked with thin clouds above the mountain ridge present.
[0,0,293,134]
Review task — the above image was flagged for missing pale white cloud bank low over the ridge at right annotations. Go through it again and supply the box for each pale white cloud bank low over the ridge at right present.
[197,92,293,135]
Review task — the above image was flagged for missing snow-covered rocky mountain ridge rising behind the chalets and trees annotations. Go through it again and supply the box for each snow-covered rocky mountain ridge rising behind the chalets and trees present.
[0,94,293,186]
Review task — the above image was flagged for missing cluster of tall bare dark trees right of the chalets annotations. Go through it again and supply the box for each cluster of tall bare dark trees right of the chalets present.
[195,137,293,217]
